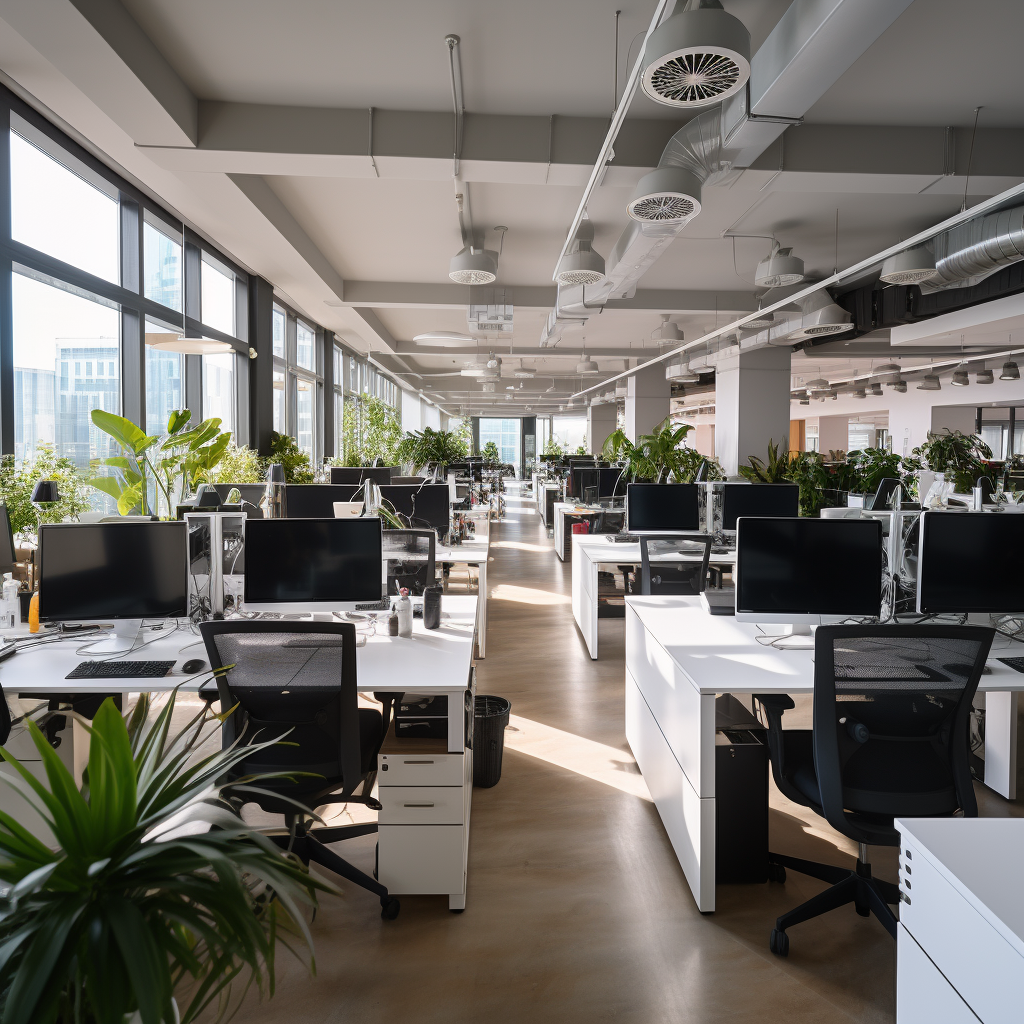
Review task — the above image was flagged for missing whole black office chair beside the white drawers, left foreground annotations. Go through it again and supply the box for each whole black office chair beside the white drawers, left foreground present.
[200,620,400,921]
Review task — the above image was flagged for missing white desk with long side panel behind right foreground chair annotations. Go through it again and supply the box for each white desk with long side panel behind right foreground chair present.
[626,597,1024,911]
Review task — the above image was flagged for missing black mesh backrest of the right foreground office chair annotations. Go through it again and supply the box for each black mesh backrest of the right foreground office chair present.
[814,626,993,842]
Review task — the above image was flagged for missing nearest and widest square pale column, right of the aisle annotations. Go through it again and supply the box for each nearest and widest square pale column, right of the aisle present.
[715,348,790,479]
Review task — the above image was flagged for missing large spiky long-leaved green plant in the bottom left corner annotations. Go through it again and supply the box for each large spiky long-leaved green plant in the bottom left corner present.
[0,694,331,1024]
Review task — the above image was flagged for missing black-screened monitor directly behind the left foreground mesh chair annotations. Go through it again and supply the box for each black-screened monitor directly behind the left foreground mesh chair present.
[245,516,384,611]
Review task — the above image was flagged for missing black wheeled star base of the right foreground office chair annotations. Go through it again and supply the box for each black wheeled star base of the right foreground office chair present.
[768,853,899,956]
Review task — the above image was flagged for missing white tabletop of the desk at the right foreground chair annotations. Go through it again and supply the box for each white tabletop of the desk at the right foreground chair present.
[623,598,1024,693]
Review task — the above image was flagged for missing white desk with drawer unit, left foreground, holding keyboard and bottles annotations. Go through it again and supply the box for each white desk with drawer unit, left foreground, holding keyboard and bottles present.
[0,594,478,910]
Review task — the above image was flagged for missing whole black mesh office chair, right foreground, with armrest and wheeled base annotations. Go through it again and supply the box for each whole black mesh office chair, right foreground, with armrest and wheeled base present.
[755,626,994,956]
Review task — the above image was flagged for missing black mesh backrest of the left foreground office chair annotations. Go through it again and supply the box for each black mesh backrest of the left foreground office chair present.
[200,620,360,795]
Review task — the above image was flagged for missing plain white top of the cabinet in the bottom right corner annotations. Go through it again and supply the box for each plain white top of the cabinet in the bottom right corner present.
[896,818,1024,956]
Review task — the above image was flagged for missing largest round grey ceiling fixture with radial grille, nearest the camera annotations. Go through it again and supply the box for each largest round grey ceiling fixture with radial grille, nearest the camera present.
[641,0,751,108]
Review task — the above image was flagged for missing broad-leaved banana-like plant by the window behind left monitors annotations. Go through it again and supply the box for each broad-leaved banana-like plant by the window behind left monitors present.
[89,409,231,518]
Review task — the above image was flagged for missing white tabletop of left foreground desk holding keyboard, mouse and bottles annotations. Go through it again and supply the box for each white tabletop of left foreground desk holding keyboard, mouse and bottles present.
[0,594,477,693]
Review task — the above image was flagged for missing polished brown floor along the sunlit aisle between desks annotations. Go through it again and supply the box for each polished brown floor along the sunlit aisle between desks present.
[224,487,1021,1024]
